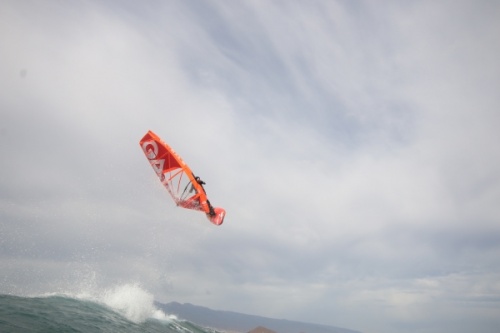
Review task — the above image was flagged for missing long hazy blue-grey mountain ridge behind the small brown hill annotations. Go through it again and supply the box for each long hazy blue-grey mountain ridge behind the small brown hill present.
[156,302,360,333]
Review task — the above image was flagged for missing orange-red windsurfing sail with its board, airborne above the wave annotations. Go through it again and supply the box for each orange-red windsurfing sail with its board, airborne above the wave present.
[139,131,226,225]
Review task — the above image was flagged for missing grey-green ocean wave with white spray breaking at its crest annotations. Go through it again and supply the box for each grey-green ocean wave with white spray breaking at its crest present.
[0,285,223,333]
